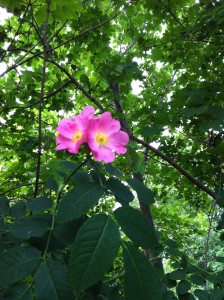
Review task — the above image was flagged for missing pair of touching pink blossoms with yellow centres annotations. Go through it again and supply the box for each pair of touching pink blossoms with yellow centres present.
[56,106,129,163]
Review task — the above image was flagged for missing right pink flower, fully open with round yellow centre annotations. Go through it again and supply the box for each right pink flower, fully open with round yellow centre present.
[87,112,129,163]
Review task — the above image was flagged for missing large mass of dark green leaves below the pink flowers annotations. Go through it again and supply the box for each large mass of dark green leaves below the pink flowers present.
[0,161,160,299]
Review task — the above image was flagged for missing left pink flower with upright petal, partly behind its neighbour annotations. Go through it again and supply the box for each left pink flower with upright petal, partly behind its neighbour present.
[56,106,95,154]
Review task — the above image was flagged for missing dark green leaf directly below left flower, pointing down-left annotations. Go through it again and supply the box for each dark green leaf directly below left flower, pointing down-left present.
[56,183,104,223]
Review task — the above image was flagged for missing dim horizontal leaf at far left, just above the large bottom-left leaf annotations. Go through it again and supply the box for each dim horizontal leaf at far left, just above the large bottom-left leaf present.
[8,216,49,240]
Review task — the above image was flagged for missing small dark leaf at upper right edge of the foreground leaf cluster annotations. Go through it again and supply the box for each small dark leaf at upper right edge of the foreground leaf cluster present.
[127,179,154,205]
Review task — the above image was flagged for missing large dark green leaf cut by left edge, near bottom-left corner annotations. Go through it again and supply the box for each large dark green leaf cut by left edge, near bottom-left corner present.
[0,247,40,287]
